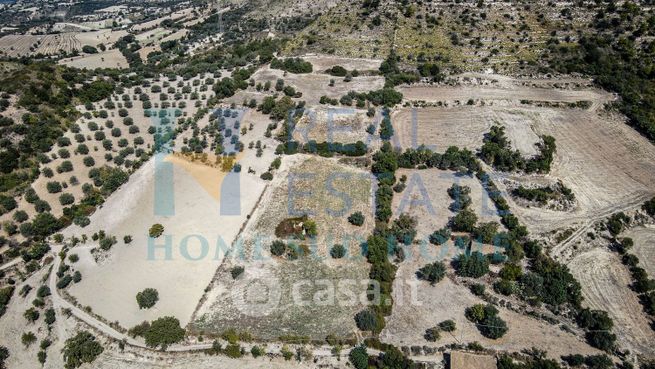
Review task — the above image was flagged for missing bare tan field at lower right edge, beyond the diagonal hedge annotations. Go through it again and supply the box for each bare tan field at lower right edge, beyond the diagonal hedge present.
[568,249,655,357]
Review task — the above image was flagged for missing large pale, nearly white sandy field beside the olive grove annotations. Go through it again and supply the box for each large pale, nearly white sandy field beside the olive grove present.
[64,152,263,327]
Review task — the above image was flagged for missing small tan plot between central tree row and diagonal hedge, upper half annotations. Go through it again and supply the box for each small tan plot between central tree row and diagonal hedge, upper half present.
[392,169,500,242]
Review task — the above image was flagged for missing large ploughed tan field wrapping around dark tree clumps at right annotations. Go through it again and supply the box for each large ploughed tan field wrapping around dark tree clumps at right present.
[392,88,655,240]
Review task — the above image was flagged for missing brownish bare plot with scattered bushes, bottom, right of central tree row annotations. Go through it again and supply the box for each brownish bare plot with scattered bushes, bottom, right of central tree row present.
[380,260,599,359]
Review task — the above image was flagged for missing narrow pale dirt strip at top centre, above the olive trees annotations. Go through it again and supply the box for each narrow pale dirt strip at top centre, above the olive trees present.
[252,67,384,106]
